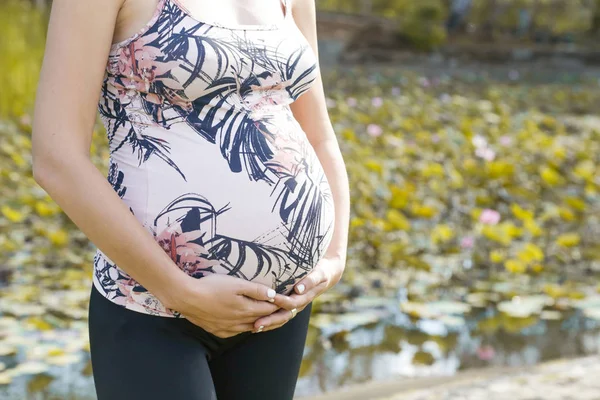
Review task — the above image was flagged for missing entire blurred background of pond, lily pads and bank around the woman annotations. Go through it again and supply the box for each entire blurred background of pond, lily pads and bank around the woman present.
[0,0,600,400]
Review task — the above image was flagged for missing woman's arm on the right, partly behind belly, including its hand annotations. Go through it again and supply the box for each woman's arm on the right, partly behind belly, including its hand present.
[254,0,350,331]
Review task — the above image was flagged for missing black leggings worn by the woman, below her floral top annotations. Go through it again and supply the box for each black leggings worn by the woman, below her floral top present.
[89,285,312,400]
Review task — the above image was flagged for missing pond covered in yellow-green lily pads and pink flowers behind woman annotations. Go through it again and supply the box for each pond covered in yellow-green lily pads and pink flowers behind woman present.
[0,0,600,400]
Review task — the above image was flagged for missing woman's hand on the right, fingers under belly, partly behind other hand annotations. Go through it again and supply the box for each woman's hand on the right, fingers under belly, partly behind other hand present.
[254,257,345,333]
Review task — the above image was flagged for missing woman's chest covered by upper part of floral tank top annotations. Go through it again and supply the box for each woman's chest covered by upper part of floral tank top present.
[107,7,318,107]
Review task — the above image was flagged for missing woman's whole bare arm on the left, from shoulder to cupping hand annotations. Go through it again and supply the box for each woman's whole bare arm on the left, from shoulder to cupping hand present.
[32,0,280,334]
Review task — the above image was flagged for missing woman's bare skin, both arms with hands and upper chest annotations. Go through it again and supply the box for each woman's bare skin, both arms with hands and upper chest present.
[32,0,349,337]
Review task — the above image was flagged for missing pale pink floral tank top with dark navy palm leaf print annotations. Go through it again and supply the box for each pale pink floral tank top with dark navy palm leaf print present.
[93,0,334,317]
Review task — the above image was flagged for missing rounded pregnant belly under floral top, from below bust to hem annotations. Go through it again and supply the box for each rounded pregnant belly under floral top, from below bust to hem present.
[95,118,334,314]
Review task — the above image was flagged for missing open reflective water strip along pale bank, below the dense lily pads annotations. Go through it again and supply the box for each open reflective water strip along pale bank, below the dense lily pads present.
[0,302,600,400]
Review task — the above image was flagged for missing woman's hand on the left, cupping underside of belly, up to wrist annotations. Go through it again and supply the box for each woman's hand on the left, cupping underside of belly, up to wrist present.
[172,273,282,338]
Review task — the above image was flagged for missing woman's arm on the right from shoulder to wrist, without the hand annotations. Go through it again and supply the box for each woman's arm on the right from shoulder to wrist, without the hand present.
[290,0,350,284]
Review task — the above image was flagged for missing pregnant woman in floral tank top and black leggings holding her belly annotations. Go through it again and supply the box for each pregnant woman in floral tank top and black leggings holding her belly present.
[32,0,350,400]
